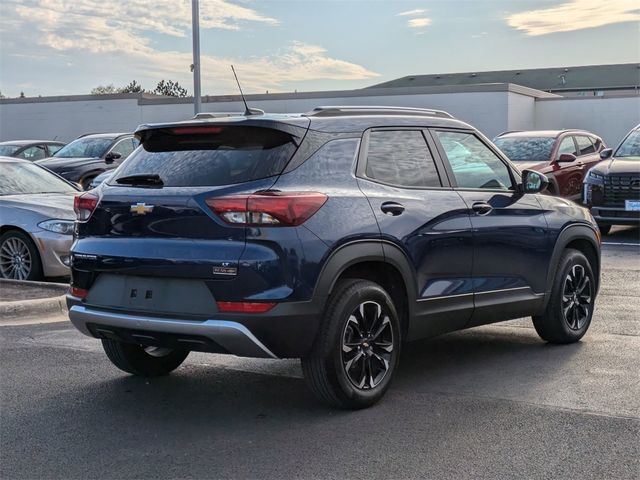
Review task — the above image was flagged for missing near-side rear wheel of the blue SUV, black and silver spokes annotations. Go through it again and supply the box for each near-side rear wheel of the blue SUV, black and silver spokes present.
[302,279,401,409]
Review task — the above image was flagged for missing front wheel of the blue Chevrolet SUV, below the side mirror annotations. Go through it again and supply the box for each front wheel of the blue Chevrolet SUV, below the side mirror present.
[533,249,596,344]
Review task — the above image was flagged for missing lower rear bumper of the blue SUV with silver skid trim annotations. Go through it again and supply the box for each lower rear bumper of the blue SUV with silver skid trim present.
[67,295,326,358]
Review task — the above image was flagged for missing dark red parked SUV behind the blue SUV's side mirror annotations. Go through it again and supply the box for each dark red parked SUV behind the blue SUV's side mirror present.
[494,130,606,200]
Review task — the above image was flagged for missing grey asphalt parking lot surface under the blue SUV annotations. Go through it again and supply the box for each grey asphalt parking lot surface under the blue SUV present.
[0,229,640,479]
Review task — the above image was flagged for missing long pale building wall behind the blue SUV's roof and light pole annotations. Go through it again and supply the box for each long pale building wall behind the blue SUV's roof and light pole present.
[0,91,509,141]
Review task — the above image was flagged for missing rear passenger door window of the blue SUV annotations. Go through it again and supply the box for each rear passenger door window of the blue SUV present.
[365,130,442,187]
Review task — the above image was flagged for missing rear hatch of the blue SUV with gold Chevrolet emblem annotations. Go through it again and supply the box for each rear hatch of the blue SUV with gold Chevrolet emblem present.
[73,118,308,316]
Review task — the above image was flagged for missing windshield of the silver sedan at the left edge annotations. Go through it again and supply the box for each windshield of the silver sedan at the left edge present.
[0,162,77,195]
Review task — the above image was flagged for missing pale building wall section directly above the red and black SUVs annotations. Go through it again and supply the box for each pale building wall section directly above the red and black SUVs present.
[535,96,640,147]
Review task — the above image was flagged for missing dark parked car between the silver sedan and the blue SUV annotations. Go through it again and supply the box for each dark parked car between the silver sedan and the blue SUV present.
[38,133,138,190]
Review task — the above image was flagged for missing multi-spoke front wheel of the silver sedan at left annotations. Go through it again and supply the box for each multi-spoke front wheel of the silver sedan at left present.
[0,230,42,280]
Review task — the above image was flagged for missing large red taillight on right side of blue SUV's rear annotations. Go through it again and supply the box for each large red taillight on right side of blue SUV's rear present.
[206,192,327,227]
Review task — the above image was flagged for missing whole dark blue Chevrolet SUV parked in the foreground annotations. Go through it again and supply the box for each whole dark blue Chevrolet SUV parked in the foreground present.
[68,107,600,408]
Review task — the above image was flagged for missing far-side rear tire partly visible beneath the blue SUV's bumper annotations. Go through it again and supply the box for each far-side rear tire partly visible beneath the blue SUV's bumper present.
[102,339,189,377]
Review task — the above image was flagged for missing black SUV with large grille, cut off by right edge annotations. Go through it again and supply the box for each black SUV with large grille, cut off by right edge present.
[583,125,640,235]
